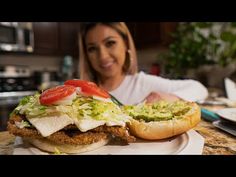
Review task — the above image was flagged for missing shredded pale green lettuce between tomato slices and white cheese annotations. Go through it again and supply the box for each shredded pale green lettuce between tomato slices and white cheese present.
[13,93,131,122]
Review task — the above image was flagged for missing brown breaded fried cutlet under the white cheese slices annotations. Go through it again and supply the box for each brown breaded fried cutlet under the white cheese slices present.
[8,115,135,145]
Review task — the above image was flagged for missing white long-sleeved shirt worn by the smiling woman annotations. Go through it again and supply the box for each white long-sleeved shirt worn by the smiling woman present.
[110,72,208,105]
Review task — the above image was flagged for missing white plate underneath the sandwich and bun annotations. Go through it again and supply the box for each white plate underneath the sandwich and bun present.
[13,130,204,155]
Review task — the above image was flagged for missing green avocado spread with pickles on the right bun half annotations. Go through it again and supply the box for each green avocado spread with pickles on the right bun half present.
[123,101,191,122]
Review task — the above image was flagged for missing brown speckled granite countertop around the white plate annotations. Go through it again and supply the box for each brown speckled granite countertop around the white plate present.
[0,120,236,155]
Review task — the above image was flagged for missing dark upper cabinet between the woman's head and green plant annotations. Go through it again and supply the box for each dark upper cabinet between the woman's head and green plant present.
[126,22,178,49]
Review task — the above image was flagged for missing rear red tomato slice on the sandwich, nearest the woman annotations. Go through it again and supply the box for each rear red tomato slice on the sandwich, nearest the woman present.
[64,79,110,98]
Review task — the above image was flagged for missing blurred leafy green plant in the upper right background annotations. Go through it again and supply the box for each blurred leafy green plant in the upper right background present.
[158,22,236,78]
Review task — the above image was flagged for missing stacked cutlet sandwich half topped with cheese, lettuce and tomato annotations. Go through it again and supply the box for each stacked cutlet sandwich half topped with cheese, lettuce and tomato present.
[7,80,135,154]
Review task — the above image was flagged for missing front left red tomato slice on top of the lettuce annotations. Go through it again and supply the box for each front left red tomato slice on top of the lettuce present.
[39,85,76,105]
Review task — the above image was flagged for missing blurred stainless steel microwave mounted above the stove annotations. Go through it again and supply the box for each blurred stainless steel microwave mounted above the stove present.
[0,22,34,52]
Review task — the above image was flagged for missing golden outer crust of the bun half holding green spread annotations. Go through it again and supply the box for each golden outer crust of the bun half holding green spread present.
[128,102,201,140]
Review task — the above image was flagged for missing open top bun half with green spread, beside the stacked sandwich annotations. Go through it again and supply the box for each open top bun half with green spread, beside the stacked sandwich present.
[123,100,201,140]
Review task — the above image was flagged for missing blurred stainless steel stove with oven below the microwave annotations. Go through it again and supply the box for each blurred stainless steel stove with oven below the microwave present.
[0,65,37,131]
